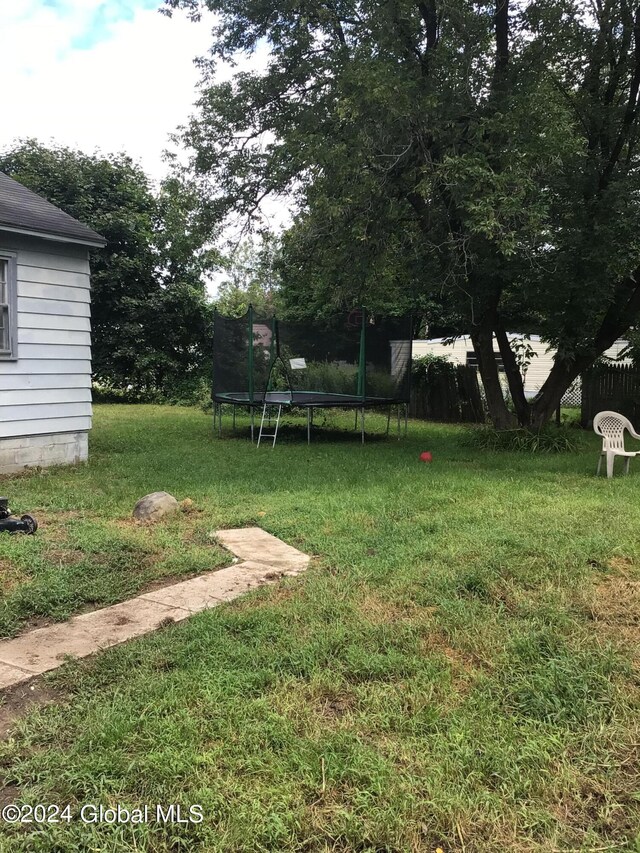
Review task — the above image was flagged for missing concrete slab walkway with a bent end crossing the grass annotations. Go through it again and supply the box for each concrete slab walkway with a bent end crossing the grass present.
[0,527,310,689]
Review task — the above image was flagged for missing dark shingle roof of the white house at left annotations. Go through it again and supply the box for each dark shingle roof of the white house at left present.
[0,172,106,246]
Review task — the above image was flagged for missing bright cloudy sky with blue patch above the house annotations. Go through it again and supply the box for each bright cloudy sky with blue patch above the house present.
[0,0,218,180]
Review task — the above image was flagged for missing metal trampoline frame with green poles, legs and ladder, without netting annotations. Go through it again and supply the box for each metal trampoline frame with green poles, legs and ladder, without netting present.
[212,305,413,444]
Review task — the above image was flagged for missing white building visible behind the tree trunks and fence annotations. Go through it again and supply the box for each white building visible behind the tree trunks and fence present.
[413,334,628,397]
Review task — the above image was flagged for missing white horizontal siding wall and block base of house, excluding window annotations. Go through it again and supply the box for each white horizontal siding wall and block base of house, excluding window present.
[0,231,91,473]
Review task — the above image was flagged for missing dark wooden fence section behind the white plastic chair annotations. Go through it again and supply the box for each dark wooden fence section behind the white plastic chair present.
[581,364,640,427]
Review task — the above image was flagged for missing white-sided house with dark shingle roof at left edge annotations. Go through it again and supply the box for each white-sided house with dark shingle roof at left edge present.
[0,172,105,474]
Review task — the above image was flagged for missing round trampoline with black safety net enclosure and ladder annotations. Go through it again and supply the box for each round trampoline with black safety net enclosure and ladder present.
[212,306,412,444]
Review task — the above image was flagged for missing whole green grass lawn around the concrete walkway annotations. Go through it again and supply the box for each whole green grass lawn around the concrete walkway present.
[0,406,640,853]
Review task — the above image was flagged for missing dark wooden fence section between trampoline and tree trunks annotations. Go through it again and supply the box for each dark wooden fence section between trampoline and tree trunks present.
[409,364,485,423]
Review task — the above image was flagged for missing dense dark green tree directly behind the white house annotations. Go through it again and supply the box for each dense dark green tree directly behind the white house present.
[0,140,214,393]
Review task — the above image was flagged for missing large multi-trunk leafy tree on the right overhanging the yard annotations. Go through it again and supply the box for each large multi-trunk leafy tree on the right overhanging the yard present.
[166,0,640,426]
